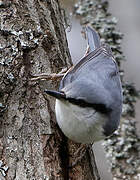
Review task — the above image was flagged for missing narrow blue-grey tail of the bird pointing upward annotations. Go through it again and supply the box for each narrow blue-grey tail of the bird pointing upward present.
[86,26,101,52]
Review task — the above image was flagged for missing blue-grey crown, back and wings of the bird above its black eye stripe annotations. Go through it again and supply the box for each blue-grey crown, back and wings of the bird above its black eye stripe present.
[60,47,121,108]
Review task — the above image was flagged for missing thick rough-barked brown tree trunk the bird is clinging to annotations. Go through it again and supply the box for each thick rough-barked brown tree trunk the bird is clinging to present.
[0,0,99,180]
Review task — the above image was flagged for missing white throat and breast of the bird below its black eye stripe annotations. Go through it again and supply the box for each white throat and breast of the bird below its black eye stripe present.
[55,99,108,143]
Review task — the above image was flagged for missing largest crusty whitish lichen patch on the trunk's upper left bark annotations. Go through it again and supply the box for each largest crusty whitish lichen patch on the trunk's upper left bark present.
[0,29,39,65]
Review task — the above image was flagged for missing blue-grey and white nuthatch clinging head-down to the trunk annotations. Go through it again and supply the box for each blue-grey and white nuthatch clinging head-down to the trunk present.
[45,26,123,144]
